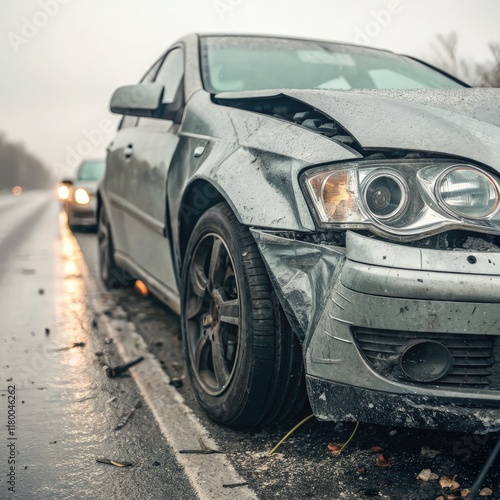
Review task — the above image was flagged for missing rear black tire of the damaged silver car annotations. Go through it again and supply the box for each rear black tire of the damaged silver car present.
[97,207,134,290]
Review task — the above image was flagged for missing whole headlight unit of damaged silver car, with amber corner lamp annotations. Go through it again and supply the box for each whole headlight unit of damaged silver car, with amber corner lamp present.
[300,159,500,241]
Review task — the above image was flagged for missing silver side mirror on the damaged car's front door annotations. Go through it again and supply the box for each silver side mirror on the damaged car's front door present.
[110,82,165,118]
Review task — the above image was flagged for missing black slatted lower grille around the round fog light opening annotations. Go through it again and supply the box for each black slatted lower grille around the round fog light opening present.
[354,328,500,390]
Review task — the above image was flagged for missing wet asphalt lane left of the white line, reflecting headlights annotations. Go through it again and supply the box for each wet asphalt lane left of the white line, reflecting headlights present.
[0,192,194,500]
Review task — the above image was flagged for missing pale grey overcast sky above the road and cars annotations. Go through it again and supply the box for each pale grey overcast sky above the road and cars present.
[0,0,500,174]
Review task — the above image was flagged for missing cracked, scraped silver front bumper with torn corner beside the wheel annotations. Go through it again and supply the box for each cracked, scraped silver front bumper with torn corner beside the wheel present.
[253,230,500,432]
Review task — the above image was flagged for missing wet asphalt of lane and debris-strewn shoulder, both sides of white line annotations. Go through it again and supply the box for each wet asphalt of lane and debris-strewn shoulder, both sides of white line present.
[0,189,500,500]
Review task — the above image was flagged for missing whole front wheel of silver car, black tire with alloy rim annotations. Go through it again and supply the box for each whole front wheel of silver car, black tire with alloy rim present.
[182,203,306,427]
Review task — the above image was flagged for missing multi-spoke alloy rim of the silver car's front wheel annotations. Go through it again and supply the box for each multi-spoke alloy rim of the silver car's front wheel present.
[185,233,241,396]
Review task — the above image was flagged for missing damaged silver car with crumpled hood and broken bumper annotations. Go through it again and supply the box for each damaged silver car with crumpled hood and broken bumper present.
[98,35,500,432]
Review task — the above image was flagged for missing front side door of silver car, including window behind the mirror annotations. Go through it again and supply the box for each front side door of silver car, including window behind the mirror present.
[106,46,184,294]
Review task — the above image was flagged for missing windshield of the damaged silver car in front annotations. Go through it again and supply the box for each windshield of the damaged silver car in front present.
[201,36,463,93]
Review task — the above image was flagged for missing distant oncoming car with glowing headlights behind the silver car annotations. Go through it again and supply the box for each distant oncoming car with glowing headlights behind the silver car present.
[65,160,106,229]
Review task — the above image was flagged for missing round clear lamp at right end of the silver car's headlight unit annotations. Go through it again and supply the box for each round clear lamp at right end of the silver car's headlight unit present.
[436,166,500,219]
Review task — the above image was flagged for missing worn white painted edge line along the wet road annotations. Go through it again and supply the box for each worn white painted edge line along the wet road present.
[65,224,258,500]
